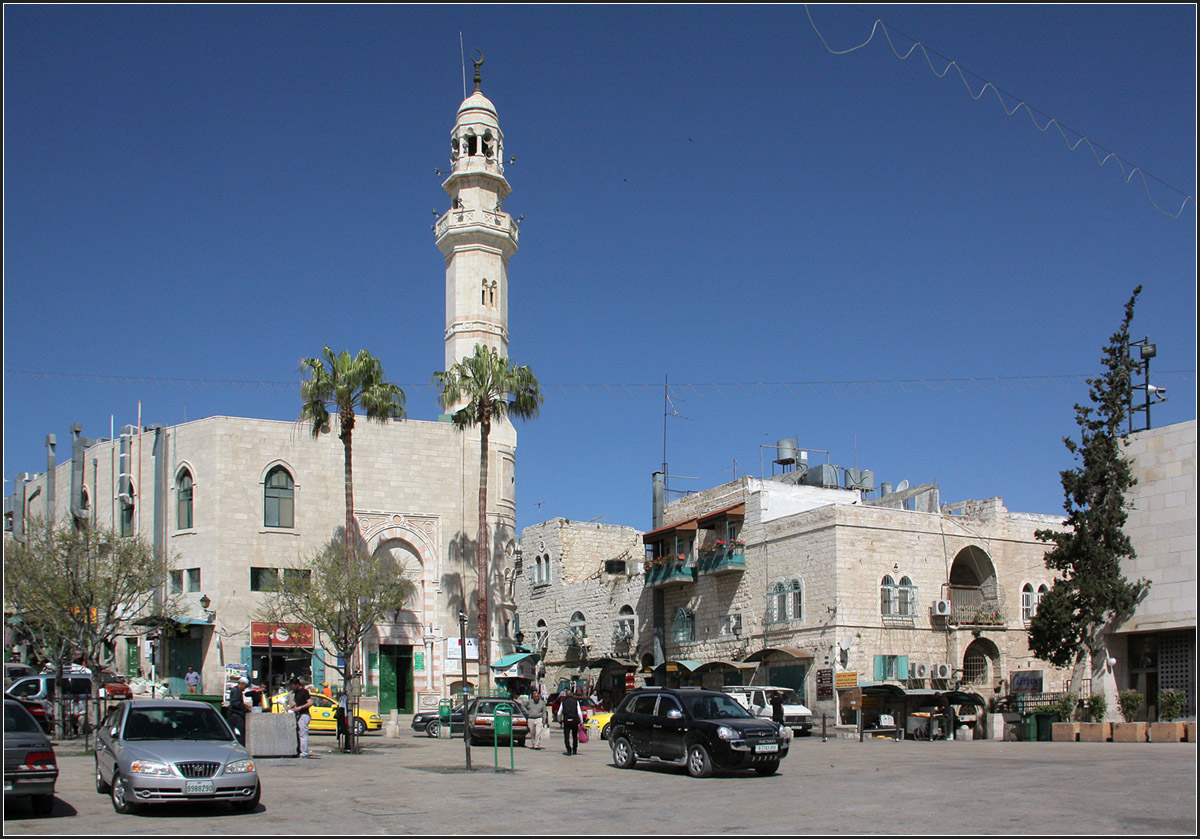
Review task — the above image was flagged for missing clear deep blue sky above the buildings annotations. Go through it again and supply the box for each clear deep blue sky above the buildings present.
[4,5,1196,529]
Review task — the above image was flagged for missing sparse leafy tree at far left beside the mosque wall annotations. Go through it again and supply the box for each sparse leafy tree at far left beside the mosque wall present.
[4,519,172,719]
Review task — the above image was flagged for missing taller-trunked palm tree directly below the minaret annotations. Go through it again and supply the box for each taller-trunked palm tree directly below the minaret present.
[433,344,542,679]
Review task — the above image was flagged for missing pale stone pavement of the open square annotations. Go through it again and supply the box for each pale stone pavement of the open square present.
[4,730,1196,835]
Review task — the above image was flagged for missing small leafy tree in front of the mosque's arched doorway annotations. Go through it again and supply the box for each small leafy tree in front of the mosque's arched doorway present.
[259,537,416,751]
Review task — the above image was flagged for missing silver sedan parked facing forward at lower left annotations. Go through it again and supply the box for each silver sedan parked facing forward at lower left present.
[96,700,262,814]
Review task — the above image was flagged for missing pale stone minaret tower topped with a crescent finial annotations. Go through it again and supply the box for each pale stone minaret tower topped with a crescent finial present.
[434,55,517,379]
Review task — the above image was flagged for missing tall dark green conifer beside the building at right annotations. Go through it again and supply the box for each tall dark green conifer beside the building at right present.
[1028,286,1150,685]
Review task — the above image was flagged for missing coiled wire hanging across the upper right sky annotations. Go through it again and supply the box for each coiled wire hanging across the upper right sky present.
[804,4,1196,218]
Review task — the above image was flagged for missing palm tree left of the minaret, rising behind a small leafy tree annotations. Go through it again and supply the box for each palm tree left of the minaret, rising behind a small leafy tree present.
[300,346,404,556]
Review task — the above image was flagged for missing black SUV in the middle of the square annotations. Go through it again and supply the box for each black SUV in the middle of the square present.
[610,688,788,778]
